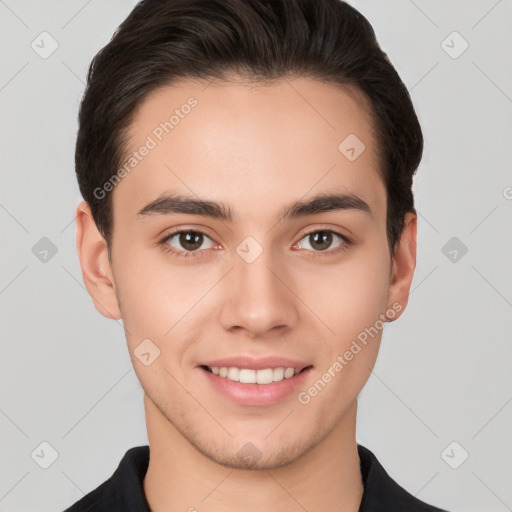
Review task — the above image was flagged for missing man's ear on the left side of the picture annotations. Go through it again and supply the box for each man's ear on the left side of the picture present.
[76,201,121,320]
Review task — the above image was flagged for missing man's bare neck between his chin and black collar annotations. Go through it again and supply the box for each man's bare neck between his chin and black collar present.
[143,394,364,512]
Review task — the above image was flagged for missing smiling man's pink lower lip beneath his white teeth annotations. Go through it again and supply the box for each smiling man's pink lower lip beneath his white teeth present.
[199,366,313,406]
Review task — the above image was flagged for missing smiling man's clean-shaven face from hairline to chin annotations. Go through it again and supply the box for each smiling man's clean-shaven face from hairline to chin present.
[79,78,415,468]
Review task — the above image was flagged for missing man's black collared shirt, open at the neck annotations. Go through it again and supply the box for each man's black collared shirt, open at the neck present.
[64,444,447,512]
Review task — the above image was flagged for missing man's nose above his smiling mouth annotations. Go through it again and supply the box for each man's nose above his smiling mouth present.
[220,251,299,337]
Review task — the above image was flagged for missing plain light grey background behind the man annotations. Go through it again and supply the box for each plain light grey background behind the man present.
[0,0,512,512]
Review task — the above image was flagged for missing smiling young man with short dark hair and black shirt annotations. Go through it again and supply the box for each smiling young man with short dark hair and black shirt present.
[67,0,452,512]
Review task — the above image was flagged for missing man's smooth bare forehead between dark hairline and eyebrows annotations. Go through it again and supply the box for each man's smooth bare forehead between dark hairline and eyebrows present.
[113,78,385,222]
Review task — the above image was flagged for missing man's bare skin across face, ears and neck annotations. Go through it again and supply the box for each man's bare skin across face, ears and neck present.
[76,77,417,512]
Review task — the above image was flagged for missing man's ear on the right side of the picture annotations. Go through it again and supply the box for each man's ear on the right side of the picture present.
[387,212,418,322]
